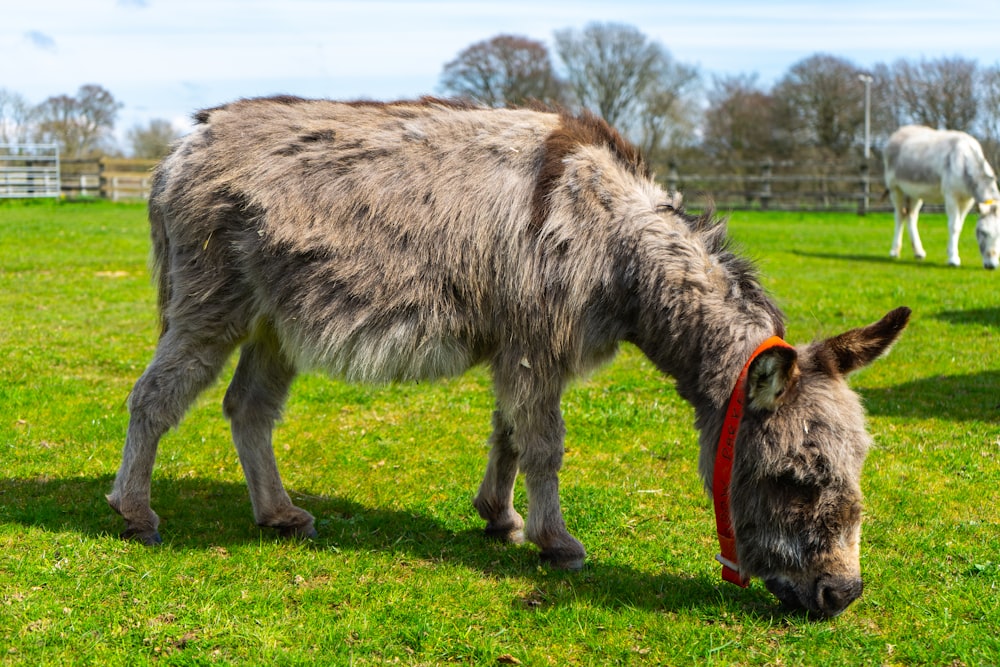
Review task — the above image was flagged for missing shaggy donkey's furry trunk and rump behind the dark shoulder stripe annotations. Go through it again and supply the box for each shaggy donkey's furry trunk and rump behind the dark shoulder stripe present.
[150,98,572,382]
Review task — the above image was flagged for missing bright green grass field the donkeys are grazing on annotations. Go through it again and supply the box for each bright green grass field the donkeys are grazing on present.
[0,203,1000,665]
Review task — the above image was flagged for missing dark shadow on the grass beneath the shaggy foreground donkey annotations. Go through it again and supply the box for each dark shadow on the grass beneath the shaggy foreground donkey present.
[0,476,780,619]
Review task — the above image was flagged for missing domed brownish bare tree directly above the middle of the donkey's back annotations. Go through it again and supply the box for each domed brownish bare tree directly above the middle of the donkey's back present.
[441,35,562,107]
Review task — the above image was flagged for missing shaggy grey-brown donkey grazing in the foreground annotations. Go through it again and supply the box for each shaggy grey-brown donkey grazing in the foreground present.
[108,97,909,615]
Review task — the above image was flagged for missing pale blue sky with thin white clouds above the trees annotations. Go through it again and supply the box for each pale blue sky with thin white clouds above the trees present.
[0,0,1000,147]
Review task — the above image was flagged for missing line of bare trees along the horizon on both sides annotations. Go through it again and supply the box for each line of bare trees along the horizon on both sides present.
[0,23,1000,173]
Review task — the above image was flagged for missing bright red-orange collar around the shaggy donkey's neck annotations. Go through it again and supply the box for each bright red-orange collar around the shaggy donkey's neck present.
[712,336,791,588]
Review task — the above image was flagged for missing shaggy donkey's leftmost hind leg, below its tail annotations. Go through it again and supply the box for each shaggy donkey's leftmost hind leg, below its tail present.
[107,328,235,545]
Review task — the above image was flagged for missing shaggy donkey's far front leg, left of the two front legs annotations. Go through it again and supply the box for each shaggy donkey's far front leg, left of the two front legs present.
[472,409,524,544]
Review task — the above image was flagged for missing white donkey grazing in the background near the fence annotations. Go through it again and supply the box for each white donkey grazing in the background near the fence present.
[885,125,1000,269]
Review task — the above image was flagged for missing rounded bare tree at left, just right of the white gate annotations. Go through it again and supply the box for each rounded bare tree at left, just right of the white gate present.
[35,84,122,158]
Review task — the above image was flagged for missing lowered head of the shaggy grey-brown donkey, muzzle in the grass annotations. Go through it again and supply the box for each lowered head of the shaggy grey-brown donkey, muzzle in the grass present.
[730,308,910,616]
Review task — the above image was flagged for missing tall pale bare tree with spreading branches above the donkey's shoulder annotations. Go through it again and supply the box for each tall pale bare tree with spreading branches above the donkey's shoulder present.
[555,23,700,164]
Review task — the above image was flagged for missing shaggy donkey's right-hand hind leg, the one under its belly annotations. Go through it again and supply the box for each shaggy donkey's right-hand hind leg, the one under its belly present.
[222,324,316,537]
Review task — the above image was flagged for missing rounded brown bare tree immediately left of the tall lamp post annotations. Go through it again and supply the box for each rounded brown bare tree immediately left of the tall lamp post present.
[773,54,865,159]
